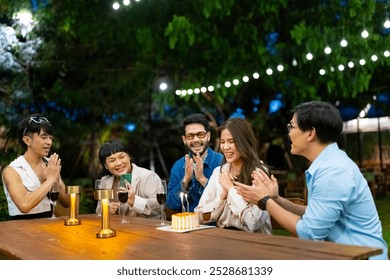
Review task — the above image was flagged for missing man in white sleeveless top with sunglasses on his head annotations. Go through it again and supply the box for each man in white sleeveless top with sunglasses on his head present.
[2,114,69,219]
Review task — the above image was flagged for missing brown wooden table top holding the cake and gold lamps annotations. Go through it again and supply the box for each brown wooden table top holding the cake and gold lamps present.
[0,214,382,260]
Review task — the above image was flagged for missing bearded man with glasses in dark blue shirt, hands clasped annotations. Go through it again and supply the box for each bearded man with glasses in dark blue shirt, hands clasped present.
[167,114,223,212]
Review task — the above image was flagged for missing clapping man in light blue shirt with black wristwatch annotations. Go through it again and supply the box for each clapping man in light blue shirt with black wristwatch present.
[237,101,388,259]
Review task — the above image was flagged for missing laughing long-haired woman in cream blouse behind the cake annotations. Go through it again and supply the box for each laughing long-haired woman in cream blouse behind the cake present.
[195,118,272,234]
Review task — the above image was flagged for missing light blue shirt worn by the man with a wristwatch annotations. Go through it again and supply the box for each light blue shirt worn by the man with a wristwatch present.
[296,143,388,259]
